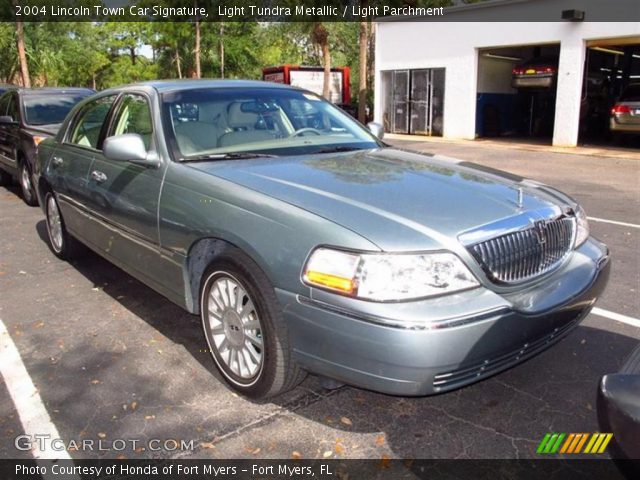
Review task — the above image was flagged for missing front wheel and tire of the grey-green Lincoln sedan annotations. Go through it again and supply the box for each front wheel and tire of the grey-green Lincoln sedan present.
[200,250,306,399]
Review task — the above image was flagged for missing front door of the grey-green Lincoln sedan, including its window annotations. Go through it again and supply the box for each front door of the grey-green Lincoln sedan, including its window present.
[82,92,166,285]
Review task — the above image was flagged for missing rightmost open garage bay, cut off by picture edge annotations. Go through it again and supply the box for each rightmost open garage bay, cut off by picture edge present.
[578,38,640,148]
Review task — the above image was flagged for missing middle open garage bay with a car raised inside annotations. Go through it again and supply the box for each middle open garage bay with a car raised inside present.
[476,44,560,144]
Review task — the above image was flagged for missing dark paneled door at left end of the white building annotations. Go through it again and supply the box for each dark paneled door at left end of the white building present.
[382,68,445,136]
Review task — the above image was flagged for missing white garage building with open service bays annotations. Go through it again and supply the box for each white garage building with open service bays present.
[375,0,640,146]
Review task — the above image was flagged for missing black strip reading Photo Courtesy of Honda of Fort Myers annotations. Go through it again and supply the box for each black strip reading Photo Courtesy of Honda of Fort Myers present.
[0,459,640,480]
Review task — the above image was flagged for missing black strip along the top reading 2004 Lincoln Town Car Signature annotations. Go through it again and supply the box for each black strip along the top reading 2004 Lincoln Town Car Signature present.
[0,0,640,22]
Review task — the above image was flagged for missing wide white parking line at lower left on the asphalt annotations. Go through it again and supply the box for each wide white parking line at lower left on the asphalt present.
[0,319,71,460]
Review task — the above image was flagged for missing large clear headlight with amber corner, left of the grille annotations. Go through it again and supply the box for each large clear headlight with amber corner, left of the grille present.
[303,248,478,302]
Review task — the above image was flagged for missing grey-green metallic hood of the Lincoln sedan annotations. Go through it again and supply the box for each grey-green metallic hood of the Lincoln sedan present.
[190,148,569,251]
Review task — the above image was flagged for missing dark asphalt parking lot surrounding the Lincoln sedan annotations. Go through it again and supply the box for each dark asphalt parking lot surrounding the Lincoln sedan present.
[0,141,640,459]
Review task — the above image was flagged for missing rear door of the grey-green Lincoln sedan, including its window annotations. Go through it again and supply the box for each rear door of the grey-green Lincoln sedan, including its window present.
[47,94,117,235]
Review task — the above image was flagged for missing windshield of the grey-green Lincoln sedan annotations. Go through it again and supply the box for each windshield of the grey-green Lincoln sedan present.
[162,88,379,160]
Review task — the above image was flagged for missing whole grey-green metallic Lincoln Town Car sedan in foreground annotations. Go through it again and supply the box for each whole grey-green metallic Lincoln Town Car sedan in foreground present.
[34,81,610,397]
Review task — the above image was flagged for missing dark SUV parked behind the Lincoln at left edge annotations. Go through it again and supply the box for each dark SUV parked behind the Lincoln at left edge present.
[0,88,94,205]
